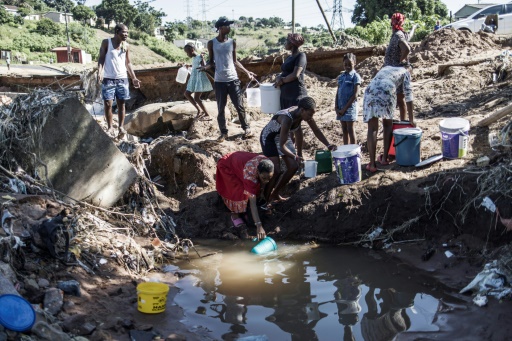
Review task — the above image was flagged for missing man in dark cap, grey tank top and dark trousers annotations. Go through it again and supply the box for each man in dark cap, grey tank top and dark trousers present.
[199,19,256,142]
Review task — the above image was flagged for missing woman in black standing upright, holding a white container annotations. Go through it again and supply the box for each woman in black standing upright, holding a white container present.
[274,33,308,109]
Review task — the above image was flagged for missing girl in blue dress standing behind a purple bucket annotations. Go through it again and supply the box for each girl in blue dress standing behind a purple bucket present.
[334,53,361,144]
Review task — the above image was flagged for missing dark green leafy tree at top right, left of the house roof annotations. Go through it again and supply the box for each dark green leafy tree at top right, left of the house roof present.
[352,0,448,26]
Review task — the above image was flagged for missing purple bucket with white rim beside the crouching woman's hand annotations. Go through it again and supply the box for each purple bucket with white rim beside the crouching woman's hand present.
[332,144,361,185]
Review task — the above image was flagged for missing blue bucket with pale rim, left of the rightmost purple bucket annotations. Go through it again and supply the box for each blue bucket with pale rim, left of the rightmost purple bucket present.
[393,128,423,166]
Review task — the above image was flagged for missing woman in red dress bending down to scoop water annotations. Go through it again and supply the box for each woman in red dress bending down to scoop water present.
[215,151,274,239]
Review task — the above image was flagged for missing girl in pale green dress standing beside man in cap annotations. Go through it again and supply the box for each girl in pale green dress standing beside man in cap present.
[184,43,213,121]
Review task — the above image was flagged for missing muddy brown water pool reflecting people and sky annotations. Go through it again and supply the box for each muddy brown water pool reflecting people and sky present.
[155,240,464,340]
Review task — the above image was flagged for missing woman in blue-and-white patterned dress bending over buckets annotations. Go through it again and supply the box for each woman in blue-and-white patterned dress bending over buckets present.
[363,64,416,173]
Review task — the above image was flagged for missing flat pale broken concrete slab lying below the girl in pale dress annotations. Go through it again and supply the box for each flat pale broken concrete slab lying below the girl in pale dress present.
[124,101,223,138]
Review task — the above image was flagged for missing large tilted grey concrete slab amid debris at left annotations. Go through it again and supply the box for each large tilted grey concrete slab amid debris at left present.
[33,98,137,207]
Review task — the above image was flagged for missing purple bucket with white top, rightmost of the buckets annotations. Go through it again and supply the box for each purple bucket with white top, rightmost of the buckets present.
[439,117,469,159]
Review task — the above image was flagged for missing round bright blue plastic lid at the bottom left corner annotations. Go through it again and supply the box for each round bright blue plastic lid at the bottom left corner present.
[0,294,36,332]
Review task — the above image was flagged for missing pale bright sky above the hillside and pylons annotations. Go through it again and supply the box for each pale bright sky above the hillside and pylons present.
[86,0,510,27]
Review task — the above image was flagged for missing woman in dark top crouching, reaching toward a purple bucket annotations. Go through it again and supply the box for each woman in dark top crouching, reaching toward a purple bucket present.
[260,97,336,207]
